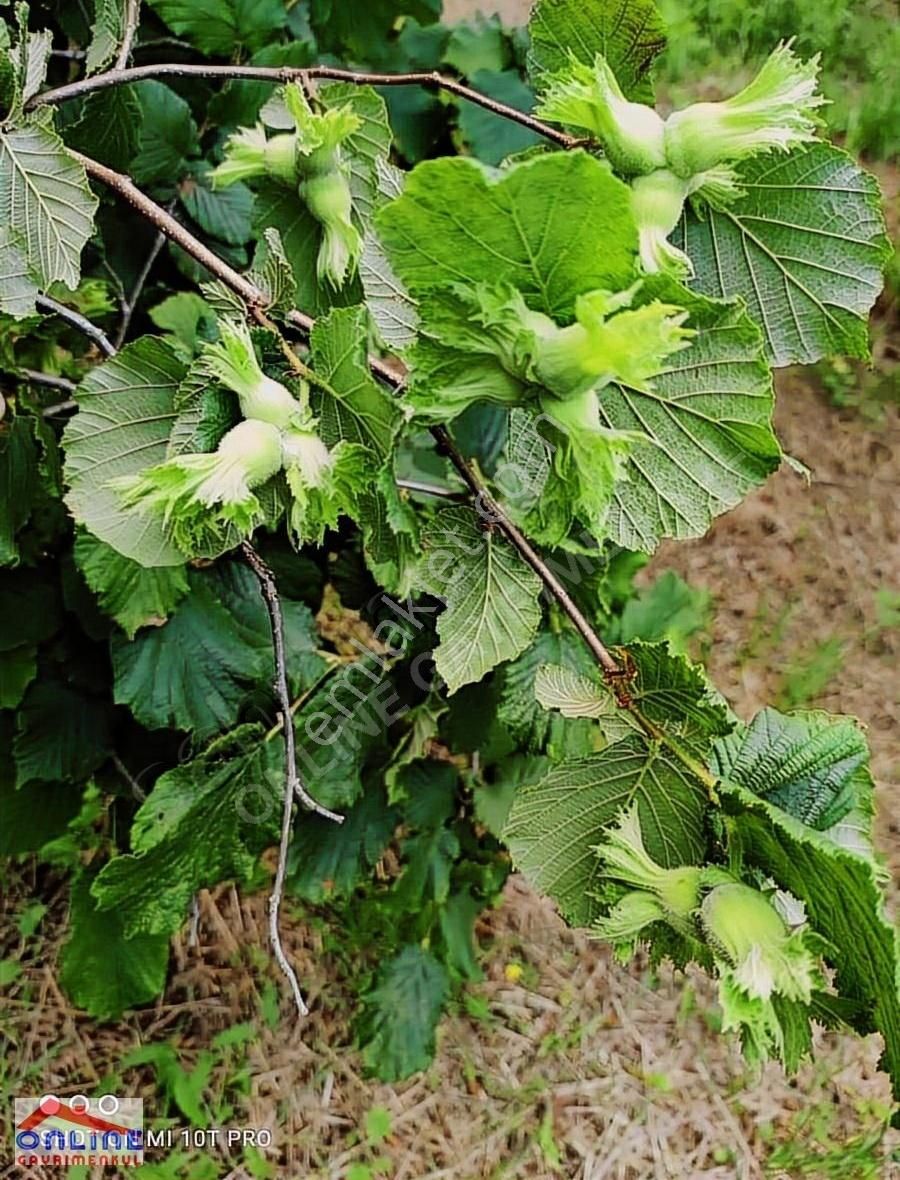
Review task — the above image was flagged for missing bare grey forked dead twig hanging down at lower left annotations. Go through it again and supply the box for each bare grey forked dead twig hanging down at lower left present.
[241,540,343,1016]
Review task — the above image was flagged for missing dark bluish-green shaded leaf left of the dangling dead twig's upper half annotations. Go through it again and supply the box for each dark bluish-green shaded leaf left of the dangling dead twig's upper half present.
[112,570,271,740]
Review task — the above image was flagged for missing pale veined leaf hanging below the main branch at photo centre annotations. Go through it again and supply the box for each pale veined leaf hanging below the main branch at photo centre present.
[421,507,541,693]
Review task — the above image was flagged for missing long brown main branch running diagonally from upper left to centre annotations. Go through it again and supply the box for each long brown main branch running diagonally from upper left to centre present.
[72,152,623,677]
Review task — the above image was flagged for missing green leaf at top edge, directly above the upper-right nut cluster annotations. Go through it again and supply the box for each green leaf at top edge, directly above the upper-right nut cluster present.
[528,0,665,103]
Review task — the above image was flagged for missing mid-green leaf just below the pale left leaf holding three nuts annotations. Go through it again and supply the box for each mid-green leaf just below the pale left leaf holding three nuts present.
[74,532,188,640]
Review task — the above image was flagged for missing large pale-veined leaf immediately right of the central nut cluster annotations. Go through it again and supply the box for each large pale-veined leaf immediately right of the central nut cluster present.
[599,283,781,552]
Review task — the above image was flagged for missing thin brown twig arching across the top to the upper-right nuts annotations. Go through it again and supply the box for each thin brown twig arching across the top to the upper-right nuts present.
[26,61,590,148]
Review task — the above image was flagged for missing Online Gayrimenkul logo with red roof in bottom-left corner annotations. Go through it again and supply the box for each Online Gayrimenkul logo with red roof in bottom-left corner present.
[15,1094,144,1168]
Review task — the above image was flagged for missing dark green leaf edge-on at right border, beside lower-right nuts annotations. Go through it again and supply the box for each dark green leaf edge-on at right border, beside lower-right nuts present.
[723,783,900,1100]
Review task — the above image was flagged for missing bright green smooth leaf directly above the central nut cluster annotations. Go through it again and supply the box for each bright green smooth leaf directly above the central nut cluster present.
[375,151,637,319]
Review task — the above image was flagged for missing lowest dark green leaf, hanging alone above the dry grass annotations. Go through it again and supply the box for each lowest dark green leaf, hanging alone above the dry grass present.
[360,946,449,1081]
